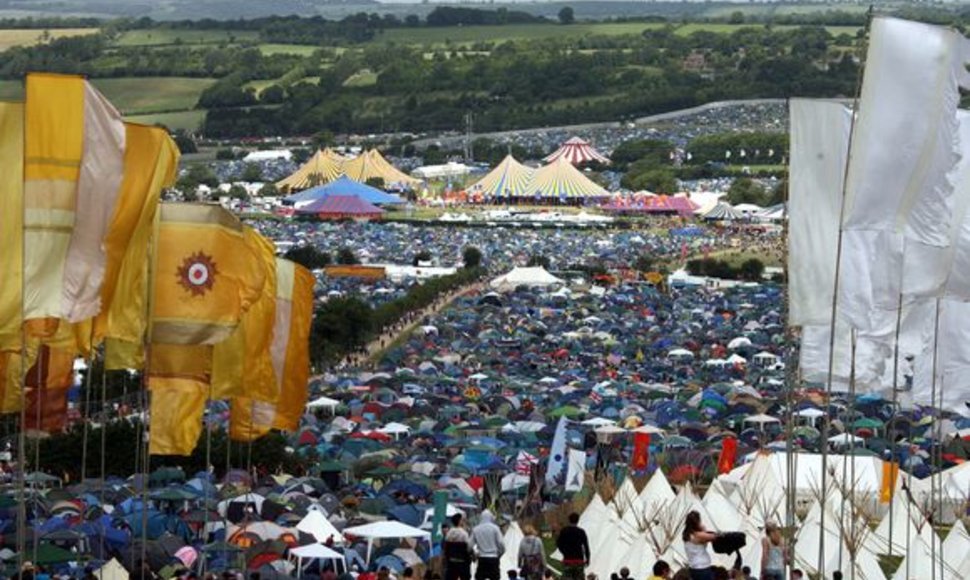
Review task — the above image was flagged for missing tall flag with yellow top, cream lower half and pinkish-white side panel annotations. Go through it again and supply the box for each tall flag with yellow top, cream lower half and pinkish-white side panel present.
[23,74,125,322]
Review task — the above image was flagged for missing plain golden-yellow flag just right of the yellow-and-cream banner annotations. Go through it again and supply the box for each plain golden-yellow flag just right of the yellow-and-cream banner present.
[95,123,179,346]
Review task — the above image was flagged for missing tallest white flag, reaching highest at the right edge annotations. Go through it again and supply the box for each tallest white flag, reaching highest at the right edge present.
[839,17,970,332]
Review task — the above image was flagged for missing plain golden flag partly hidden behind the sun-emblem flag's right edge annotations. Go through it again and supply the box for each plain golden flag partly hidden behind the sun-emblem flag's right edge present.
[211,227,279,402]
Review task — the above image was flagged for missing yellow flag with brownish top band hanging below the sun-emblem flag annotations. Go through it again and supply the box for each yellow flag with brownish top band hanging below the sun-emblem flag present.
[148,344,212,455]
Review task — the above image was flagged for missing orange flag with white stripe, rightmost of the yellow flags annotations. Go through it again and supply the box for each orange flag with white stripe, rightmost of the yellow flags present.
[229,259,315,441]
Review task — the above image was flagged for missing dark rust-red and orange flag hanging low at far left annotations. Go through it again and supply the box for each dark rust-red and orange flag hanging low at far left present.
[24,345,74,434]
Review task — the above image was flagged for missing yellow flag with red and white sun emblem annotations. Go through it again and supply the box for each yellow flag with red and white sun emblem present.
[150,203,265,345]
